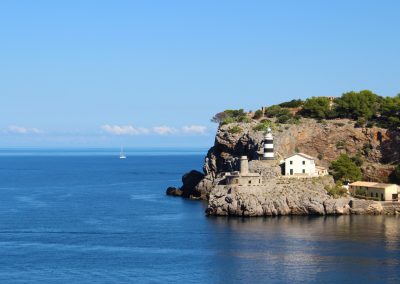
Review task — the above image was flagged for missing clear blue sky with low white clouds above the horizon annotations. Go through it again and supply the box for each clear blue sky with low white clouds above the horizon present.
[0,0,400,147]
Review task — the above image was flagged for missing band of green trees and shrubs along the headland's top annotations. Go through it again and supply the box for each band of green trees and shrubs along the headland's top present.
[211,90,400,129]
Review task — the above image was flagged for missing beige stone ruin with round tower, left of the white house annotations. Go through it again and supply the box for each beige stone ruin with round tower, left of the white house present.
[225,156,262,186]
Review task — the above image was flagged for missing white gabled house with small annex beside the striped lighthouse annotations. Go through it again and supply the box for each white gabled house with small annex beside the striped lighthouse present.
[283,153,328,176]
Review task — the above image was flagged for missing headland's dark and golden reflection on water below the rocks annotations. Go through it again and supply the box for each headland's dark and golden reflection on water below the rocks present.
[209,216,400,282]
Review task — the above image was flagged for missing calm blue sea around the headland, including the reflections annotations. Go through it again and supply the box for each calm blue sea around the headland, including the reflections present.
[0,149,400,283]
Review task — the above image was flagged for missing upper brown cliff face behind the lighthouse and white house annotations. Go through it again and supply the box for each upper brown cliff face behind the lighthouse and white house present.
[191,118,400,199]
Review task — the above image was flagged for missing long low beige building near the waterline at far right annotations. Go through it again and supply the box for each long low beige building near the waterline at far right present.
[349,181,399,201]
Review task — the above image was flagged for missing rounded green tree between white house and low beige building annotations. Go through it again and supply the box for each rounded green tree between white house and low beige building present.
[330,154,361,182]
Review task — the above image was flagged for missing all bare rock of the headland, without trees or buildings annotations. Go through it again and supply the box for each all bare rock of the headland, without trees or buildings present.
[166,119,400,216]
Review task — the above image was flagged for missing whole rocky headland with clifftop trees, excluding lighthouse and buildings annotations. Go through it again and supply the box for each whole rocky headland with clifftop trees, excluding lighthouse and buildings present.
[167,91,400,216]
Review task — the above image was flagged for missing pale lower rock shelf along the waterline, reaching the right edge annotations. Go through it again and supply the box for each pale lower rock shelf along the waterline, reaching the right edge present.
[206,177,400,217]
